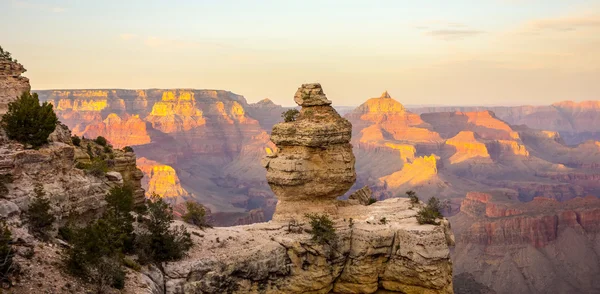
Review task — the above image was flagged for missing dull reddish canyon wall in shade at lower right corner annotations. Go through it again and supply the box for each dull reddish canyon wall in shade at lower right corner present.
[451,193,600,293]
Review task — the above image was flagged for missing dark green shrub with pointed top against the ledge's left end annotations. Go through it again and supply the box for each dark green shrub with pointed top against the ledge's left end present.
[136,194,193,263]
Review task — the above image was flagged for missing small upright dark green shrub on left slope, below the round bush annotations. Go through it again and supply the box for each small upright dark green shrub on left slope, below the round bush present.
[27,184,56,240]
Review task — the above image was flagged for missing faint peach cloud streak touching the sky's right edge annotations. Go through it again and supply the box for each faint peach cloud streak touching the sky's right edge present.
[523,16,600,33]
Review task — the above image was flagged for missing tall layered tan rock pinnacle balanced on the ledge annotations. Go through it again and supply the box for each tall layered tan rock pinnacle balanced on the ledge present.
[263,84,356,220]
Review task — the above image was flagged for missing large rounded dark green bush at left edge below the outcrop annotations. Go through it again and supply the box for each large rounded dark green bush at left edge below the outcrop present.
[2,92,58,148]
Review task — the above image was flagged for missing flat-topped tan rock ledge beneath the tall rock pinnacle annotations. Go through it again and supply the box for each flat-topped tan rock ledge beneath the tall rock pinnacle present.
[135,198,454,294]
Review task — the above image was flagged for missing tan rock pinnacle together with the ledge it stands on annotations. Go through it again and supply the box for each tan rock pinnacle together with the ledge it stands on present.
[137,84,454,293]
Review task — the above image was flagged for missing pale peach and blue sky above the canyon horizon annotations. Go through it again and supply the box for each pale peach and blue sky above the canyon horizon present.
[0,0,600,106]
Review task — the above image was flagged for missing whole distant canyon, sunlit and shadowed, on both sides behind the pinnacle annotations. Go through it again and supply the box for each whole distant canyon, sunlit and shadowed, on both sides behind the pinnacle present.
[37,89,600,293]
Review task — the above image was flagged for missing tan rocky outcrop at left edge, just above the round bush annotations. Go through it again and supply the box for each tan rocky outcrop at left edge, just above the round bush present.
[0,57,31,115]
